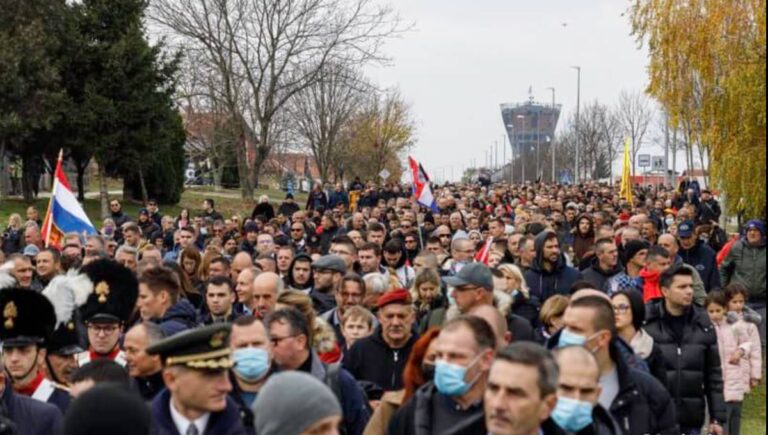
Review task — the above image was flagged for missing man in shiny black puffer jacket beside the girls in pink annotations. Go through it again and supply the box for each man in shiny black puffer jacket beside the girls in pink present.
[645,266,726,434]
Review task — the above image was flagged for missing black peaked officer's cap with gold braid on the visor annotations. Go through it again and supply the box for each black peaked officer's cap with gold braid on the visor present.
[146,323,234,370]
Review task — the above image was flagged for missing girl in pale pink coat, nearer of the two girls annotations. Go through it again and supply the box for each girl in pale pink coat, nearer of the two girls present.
[704,290,752,435]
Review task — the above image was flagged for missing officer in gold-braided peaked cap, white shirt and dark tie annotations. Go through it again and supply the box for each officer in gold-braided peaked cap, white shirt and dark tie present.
[146,323,247,435]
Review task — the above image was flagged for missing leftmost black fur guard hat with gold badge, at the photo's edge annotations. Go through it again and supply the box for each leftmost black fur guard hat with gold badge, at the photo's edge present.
[0,288,56,347]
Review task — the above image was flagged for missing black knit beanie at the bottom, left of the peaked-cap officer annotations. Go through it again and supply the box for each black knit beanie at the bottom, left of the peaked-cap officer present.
[64,382,151,435]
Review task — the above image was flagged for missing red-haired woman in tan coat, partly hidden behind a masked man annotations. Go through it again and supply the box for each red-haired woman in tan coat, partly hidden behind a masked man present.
[363,328,440,435]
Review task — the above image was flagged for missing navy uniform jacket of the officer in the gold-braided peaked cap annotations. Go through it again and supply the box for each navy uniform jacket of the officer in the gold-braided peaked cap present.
[150,390,248,435]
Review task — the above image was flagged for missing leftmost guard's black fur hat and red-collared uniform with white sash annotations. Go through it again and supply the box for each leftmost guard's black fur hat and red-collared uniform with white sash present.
[0,288,70,413]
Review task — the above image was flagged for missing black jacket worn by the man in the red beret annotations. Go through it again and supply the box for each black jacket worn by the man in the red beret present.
[344,326,419,391]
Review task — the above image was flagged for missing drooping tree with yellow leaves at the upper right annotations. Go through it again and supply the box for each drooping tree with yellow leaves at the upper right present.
[630,0,766,216]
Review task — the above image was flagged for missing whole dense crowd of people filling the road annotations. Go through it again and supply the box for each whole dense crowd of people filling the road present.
[0,179,766,435]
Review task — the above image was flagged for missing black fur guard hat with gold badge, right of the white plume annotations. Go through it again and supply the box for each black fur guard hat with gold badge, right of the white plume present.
[80,259,139,323]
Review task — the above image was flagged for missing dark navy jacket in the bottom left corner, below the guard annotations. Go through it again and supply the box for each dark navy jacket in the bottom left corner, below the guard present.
[2,382,64,435]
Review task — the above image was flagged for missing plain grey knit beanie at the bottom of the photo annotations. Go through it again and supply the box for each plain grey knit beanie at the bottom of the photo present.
[253,371,341,435]
